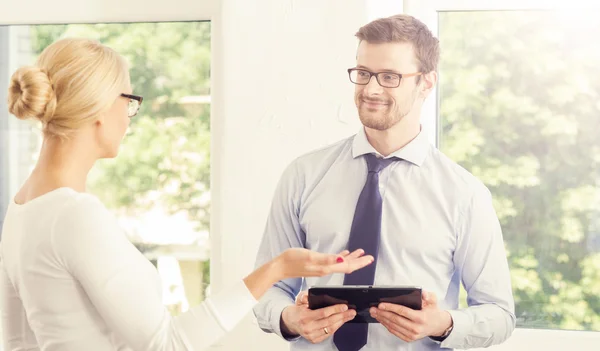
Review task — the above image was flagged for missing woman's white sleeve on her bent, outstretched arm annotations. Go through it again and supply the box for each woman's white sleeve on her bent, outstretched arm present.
[52,197,256,351]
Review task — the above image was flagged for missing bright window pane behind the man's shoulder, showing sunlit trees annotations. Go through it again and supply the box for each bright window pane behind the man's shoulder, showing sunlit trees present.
[439,11,600,331]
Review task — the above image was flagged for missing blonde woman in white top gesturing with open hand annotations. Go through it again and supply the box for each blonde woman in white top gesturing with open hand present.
[0,39,373,351]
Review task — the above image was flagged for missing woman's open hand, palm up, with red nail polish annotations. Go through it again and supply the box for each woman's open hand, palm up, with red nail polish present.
[274,248,374,279]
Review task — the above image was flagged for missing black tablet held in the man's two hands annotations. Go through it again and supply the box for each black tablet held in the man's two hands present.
[308,285,422,323]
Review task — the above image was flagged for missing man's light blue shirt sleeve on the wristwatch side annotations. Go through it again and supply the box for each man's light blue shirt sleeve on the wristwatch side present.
[441,184,516,349]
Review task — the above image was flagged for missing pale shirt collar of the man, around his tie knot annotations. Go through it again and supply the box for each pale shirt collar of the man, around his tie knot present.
[352,127,429,167]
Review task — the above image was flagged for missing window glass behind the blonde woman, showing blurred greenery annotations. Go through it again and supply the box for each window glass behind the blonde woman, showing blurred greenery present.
[0,21,211,320]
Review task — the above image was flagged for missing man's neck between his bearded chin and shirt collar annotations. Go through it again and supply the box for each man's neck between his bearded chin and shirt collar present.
[365,115,421,156]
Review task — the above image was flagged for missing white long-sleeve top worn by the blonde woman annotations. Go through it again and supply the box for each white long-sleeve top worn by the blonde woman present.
[0,188,256,351]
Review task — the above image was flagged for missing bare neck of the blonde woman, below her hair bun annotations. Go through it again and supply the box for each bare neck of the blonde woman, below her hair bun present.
[30,136,96,192]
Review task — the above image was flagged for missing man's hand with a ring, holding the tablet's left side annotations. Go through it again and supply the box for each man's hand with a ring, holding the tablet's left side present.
[281,298,356,344]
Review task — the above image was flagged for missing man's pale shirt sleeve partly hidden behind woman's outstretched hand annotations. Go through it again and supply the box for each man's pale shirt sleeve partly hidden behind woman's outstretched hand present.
[254,161,306,341]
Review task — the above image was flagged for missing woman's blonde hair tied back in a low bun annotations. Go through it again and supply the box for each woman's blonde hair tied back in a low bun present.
[8,38,129,138]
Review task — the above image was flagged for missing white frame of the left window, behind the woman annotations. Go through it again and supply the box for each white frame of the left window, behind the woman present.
[0,0,225,292]
